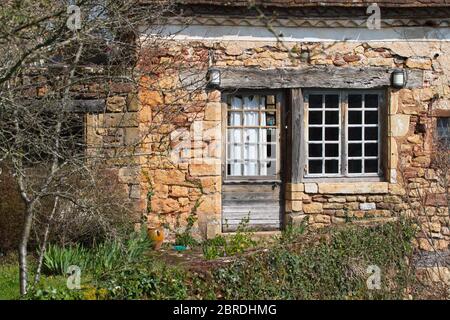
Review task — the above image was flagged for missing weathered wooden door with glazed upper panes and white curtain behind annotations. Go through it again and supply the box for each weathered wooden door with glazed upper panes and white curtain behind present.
[222,91,283,232]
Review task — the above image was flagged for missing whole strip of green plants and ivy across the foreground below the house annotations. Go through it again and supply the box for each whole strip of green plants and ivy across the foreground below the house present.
[0,221,436,299]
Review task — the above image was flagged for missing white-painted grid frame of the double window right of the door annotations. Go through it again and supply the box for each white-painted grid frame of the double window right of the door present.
[303,89,386,179]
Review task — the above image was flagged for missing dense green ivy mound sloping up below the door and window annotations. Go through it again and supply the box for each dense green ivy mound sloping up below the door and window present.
[214,221,414,299]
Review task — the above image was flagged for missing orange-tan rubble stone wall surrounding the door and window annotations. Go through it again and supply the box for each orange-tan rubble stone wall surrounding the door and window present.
[133,41,450,250]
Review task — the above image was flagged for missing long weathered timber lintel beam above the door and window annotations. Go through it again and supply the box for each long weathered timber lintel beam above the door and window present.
[219,66,423,89]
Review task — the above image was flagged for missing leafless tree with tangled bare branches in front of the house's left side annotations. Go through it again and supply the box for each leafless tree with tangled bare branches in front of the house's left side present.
[0,0,209,294]
